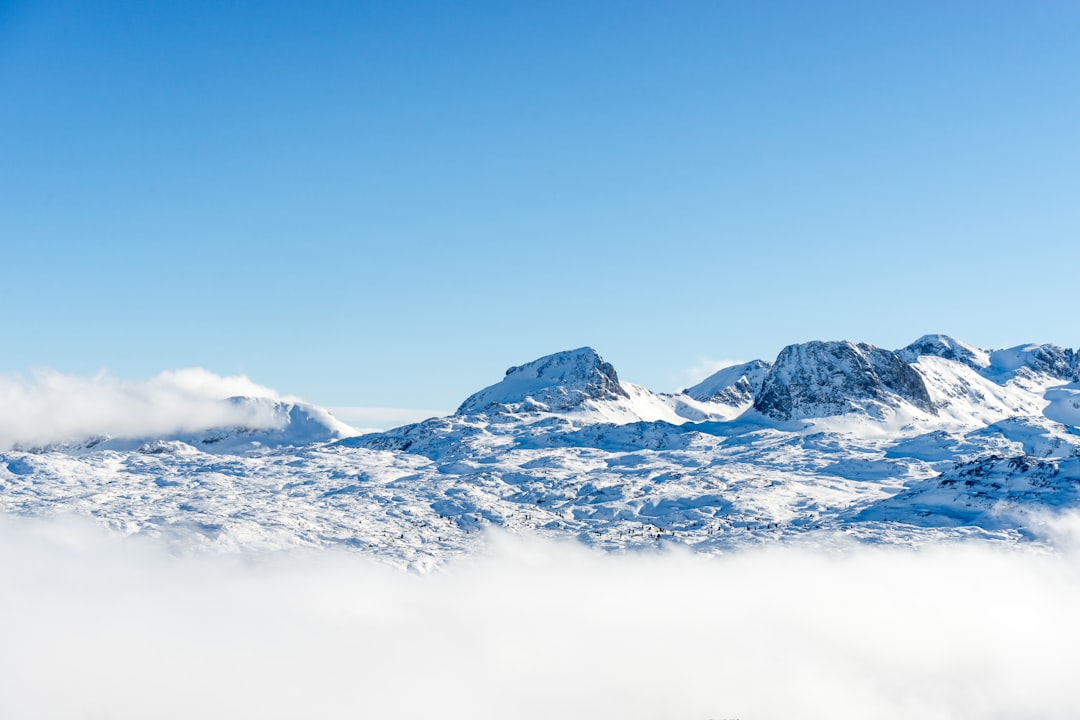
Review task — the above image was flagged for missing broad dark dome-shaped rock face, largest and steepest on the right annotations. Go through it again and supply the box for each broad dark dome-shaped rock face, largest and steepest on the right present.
[754,341,936,420]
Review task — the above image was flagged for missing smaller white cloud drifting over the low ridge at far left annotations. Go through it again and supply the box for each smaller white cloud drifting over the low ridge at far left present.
[0,368,287,450]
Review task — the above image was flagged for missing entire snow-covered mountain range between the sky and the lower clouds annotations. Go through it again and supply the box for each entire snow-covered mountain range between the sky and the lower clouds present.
[0,335,1080,567]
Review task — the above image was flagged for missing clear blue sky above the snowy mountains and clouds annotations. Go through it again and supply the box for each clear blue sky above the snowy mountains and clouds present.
[0,0,1080,408]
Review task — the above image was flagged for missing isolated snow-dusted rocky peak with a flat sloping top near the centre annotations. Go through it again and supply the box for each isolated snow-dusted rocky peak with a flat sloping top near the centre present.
[456,348,629,416]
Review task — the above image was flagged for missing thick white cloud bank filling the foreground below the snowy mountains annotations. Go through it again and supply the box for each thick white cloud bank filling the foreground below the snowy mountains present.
[0,519,1080,720]
